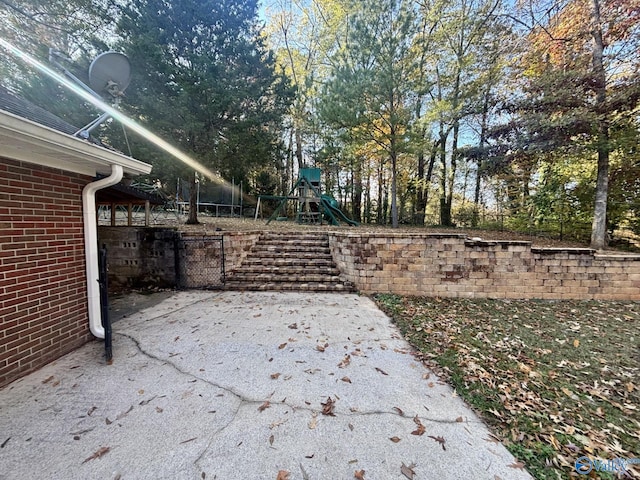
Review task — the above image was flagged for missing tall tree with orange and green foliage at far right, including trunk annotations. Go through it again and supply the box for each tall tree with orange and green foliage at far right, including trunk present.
[500,0,640,249]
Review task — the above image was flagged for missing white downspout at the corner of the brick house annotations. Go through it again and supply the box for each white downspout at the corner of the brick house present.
[82,165,123,338]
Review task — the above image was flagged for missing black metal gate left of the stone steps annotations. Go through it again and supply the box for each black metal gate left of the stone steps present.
[176,235,225,289]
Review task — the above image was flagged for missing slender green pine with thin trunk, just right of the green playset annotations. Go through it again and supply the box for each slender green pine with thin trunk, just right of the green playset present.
[321,0,415,228]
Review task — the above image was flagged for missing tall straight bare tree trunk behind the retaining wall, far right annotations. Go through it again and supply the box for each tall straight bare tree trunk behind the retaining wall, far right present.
[591,0,610,250]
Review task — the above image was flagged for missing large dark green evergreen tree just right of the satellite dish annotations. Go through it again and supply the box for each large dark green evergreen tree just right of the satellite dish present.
[117,0,290,223]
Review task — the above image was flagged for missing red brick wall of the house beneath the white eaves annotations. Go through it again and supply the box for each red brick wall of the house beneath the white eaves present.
[0,157,92,386]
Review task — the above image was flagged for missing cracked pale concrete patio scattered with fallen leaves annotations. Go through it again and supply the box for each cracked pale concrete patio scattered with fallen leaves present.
[0,291,531,480]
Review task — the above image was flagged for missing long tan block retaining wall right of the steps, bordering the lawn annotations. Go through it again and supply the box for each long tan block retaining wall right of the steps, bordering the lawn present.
[329,232,640,300]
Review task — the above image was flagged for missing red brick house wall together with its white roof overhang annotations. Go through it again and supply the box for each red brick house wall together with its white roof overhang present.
[0,100,151,387]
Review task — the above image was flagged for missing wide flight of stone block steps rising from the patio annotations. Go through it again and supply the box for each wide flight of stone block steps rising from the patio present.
[225,232,355,292]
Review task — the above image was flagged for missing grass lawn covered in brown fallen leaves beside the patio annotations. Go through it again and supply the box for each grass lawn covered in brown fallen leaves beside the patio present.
[374,294,640,479]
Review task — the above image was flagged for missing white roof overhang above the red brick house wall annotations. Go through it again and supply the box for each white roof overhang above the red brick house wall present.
[0,110,151,177]
